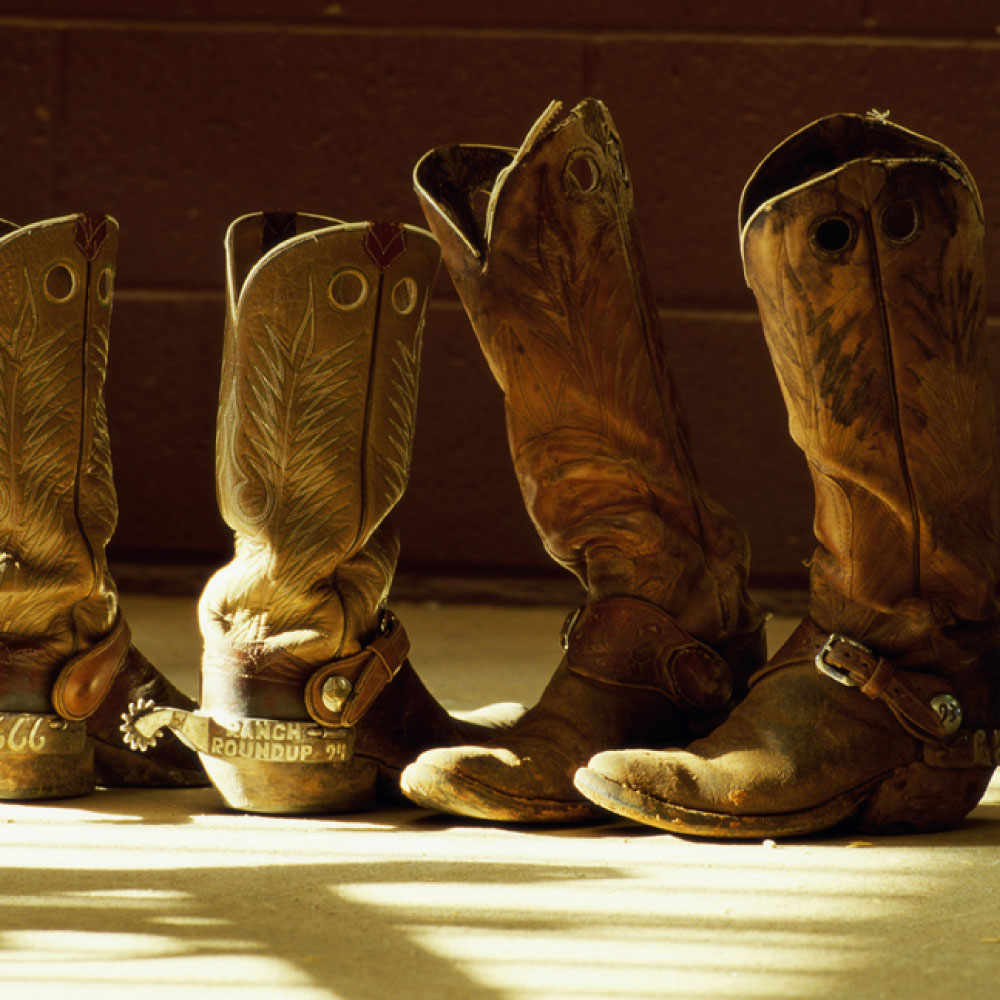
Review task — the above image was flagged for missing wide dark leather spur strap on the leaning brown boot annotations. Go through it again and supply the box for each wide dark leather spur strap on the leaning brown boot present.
[566,597,732,713]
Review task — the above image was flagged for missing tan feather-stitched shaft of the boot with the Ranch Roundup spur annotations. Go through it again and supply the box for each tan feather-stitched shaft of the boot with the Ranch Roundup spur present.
[202,213,438,688]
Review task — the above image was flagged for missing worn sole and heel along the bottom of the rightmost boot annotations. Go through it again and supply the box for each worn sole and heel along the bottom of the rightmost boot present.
[573,761,992,840]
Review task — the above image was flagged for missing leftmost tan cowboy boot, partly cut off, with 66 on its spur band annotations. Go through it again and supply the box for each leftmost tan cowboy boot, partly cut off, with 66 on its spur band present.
[0,215,207,799]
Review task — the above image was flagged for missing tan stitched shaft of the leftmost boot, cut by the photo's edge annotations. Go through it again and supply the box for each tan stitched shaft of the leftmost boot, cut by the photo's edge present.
[0,215,118,684]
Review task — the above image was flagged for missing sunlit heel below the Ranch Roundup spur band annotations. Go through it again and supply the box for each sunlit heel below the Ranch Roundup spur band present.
[199,754,378,815]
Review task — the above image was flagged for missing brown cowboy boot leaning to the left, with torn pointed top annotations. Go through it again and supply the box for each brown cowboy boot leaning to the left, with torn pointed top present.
[402,100,763,822]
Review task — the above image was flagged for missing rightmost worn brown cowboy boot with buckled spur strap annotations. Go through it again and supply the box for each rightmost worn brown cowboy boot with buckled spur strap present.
[577,113,1000,837]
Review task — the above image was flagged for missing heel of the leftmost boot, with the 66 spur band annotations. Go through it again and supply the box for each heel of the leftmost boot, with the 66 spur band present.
[0,712,94,800]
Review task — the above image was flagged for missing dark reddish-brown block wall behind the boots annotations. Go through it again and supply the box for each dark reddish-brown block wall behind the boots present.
[0,0,1000,582]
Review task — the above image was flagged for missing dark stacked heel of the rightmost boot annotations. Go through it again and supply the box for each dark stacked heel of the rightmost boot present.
[858,761,993,833]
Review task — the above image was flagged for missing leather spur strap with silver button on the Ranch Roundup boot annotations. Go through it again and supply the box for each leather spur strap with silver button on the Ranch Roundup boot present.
[305,611,410,726]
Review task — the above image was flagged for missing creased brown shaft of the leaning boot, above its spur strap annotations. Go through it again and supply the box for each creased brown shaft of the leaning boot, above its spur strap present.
[414,100,753,639]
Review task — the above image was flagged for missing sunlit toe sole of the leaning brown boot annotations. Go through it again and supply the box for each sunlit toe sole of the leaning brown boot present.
[400,764,597,823]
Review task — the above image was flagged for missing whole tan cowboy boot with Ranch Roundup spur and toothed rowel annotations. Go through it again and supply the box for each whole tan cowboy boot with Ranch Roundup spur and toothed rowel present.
[121,213,520,813]
